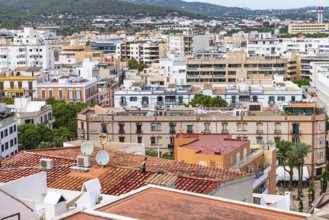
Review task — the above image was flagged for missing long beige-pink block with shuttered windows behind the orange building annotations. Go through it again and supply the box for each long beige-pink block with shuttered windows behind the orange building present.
[77,102,327,176]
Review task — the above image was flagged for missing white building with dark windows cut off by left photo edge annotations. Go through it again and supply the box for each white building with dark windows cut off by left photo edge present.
[0,104,18,158]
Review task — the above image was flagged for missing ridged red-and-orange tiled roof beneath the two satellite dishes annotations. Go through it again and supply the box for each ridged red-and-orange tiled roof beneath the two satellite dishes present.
[0,147,244,195]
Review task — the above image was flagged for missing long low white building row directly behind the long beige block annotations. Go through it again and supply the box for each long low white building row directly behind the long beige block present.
[114,76,303,111]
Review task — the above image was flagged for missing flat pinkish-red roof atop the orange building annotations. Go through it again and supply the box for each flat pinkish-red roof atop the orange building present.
[177,134,248,154]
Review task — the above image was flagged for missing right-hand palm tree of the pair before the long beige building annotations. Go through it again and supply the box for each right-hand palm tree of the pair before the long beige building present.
[292,143,311,200]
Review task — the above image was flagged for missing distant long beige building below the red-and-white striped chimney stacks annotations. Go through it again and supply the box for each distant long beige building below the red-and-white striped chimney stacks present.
[288,23,329,34]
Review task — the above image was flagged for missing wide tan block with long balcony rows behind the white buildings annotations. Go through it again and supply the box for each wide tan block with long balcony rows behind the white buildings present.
[186,52,297,84]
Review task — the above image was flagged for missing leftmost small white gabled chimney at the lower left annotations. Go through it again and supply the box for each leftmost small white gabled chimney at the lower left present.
[43,191,67,219]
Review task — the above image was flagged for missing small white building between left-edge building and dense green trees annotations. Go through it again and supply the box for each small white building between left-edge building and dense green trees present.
[8,97,55,128]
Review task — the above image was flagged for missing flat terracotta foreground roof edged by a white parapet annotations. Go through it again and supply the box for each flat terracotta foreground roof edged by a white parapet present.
[96,188,305,220]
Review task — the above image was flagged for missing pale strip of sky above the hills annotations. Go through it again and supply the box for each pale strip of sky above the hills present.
[185,0,329,9]
